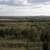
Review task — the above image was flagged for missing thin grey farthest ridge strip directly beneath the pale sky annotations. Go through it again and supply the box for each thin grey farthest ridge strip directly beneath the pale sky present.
[0,16,50,19]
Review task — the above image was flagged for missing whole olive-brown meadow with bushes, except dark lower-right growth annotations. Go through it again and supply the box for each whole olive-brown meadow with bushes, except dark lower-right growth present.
[0,16,50,50]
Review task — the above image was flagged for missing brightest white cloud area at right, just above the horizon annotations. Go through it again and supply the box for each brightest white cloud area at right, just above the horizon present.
[32,2,50,16]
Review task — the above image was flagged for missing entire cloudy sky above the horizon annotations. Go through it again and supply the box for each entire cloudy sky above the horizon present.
[0,0,50,16]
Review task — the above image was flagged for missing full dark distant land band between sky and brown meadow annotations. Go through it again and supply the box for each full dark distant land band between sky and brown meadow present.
[0,16,50,21]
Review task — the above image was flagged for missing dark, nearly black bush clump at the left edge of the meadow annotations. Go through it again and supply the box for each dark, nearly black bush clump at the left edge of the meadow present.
[0,28,16,37]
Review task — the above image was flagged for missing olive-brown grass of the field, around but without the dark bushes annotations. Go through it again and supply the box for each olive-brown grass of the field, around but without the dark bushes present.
[0,18,50,50]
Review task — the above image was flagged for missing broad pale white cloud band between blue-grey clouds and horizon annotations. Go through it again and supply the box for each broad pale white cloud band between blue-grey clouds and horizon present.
[0,4,50,16]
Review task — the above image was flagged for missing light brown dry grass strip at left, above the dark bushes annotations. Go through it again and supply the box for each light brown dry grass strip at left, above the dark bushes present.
[0,22,32,30]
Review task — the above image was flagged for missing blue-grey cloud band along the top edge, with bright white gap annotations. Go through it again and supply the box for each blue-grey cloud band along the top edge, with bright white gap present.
[0,0,50,6]
